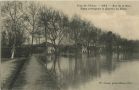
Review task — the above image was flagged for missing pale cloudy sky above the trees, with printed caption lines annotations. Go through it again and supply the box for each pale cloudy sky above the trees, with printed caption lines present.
[41,0,139,40]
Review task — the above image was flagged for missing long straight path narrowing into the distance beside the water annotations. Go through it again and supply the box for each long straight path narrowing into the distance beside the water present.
[12,55,59,90]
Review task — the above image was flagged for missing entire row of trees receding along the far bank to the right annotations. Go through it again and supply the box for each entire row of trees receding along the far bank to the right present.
[1,1,139,58]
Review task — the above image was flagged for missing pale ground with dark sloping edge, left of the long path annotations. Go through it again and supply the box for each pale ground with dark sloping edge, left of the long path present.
[1,58,26,90]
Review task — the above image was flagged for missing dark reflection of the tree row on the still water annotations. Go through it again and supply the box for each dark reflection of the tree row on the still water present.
[37,53,139,90]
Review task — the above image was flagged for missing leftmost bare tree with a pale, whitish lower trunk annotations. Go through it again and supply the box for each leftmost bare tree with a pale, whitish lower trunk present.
[1,1,25,59]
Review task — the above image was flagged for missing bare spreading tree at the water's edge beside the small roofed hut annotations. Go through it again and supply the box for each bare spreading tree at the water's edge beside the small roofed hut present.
[48,10,69,53]
